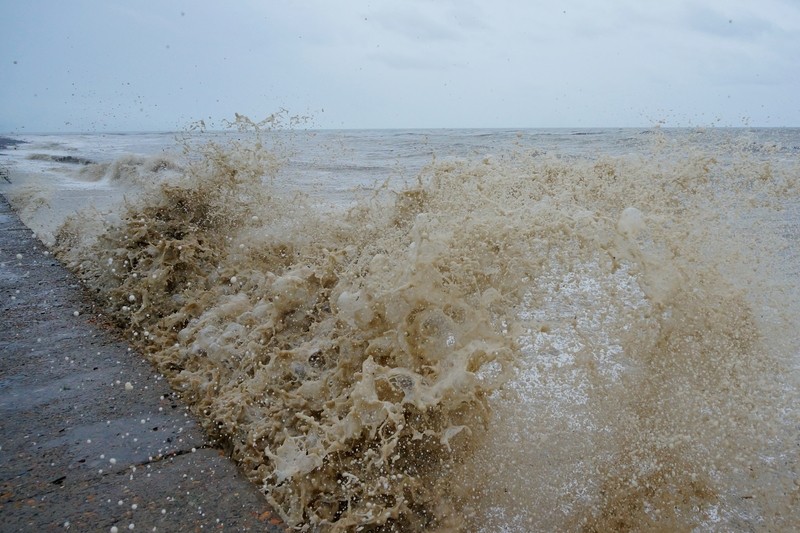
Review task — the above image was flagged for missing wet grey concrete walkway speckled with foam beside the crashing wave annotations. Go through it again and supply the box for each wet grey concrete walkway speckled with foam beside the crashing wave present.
[0,197,283,533]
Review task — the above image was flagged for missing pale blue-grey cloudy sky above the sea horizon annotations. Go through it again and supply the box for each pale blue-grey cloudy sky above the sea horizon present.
[0,0,800,133]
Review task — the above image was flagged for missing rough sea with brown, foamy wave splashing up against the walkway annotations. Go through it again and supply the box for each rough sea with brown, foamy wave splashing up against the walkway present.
[0,122,800,532]
